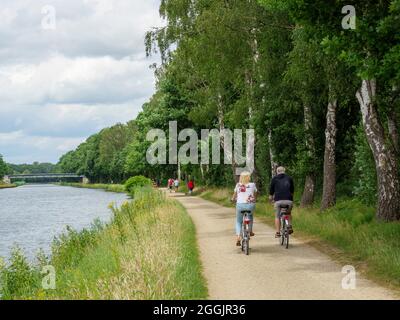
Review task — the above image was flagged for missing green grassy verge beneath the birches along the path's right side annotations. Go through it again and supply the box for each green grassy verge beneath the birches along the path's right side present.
[199,189,400,291]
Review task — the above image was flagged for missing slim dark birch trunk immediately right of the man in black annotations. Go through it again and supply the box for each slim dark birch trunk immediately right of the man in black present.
[300,105,315,207]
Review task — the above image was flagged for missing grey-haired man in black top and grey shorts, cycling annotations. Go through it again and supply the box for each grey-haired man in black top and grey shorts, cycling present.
[269,167,294,238]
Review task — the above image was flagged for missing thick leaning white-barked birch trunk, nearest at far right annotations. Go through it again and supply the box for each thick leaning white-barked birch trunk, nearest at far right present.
[356,79,400,221]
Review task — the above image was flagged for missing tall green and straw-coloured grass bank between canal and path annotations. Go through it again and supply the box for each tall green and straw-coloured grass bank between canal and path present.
[0,188,207,300]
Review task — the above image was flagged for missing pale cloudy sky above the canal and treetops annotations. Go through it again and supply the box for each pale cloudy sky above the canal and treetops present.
[0,0,162,163]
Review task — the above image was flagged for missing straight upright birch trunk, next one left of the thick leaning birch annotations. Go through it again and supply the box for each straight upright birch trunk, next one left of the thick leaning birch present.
[321,99,337,210]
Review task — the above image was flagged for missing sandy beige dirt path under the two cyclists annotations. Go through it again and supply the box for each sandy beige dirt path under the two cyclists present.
[171,193,396,300]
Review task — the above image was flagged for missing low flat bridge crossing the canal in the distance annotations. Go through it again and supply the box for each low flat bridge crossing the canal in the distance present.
[4,173,88,183]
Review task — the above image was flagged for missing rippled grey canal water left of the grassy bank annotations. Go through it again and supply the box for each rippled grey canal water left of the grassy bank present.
[0,185,127,261]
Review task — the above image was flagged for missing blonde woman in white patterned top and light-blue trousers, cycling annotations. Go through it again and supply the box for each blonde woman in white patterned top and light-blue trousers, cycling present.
[231,172,257,247]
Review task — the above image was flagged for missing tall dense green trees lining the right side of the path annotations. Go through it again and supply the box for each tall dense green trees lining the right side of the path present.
[59,0,400,221]
